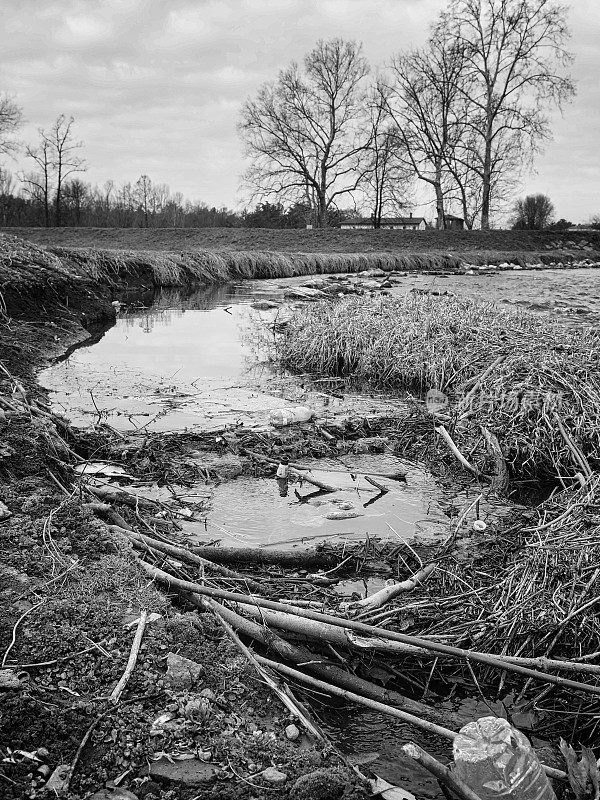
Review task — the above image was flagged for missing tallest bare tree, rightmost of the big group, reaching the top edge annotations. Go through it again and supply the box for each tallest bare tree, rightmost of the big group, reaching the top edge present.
[437,0,574,228]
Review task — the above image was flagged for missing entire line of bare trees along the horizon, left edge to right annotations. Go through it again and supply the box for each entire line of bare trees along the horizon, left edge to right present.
[0,0,574,229]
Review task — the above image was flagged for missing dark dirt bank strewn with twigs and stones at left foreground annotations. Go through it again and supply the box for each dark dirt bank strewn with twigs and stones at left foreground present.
[0,256,365,800]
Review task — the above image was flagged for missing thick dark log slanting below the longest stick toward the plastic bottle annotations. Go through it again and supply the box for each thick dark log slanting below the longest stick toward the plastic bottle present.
[187,594,464,728]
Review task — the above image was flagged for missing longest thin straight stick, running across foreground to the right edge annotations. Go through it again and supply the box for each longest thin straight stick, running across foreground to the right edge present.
[140,562,600,695]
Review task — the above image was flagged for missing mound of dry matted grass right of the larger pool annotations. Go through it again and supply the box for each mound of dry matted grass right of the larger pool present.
[279,295,600,485]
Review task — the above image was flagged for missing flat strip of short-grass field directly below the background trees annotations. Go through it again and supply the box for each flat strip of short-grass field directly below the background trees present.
[0,228,600,253]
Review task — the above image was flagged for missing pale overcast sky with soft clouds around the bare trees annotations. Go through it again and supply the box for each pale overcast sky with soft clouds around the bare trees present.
[0,0,600,222]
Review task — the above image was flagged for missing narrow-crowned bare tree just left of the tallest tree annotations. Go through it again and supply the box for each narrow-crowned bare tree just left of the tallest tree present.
[381,29,464,228]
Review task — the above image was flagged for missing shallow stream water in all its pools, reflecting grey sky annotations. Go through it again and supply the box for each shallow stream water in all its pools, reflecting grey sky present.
[39,269,600,800]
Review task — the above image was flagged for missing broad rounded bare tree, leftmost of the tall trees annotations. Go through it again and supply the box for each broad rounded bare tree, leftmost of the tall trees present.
[239,39,370,227]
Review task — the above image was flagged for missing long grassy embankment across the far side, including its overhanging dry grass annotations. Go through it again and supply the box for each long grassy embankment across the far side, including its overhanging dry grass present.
[0,228,600,286]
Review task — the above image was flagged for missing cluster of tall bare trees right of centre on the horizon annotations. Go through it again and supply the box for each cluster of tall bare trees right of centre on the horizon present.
[239,0,574,229]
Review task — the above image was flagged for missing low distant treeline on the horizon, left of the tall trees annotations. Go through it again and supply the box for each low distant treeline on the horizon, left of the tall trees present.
[0,167,355,228]
